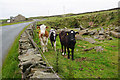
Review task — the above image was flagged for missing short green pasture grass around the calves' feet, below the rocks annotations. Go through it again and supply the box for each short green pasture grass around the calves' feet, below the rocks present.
[34,26,120,78]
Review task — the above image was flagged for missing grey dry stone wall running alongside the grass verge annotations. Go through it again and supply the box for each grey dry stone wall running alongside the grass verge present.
[18,23,59,80]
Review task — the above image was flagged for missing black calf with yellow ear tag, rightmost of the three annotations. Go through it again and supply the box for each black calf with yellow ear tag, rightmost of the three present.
[59,30,79,60]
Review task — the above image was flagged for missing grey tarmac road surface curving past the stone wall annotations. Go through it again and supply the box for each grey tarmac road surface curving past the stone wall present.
[0,22,32,66]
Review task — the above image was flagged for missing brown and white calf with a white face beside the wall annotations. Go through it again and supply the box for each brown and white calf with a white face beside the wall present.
[37,24,49,53]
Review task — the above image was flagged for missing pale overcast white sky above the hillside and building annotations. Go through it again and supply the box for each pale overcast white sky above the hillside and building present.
[0,0,119,19]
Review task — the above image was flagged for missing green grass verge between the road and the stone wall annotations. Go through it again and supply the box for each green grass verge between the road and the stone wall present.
[2,25,29,79]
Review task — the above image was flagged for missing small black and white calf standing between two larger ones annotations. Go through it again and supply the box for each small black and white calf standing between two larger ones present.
[49,29,58,51]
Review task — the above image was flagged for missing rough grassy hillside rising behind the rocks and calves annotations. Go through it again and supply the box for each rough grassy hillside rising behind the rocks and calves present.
[36,8,120,28]
